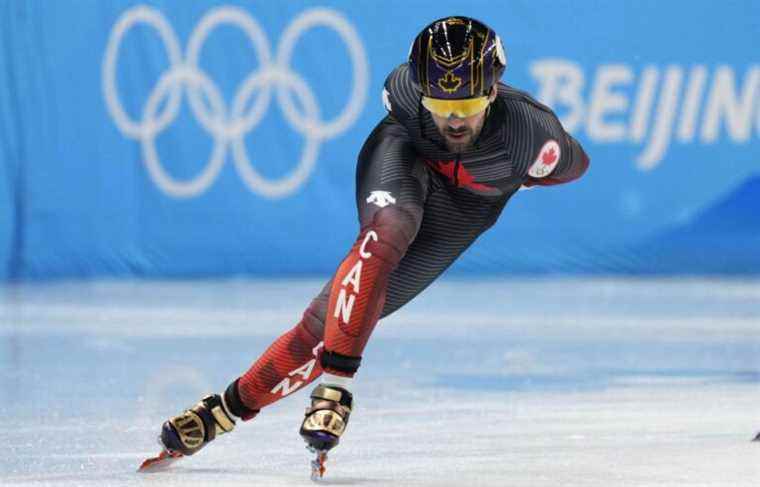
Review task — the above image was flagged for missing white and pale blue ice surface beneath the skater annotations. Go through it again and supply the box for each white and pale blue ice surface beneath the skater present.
[0,279,760,487]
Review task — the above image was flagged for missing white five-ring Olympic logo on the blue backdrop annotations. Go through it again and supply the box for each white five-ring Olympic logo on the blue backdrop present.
[102,5,369,198]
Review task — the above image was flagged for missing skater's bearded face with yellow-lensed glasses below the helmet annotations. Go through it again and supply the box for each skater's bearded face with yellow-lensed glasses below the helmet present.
[423,89,496,152]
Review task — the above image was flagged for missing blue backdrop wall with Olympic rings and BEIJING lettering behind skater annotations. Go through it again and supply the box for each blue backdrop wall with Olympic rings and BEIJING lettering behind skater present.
[0,0,760,278]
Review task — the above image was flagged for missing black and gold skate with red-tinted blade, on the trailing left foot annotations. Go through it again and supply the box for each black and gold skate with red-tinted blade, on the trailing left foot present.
[139,394,235,472]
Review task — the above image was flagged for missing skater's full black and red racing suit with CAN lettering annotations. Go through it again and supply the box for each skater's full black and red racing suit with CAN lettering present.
[226,65,588,417]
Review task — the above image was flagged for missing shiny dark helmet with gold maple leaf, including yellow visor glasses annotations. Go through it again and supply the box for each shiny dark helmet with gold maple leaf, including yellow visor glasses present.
[409,17,507,116]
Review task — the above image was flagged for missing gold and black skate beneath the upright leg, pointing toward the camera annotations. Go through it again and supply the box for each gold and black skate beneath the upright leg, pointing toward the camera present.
[301,384,353,480]
